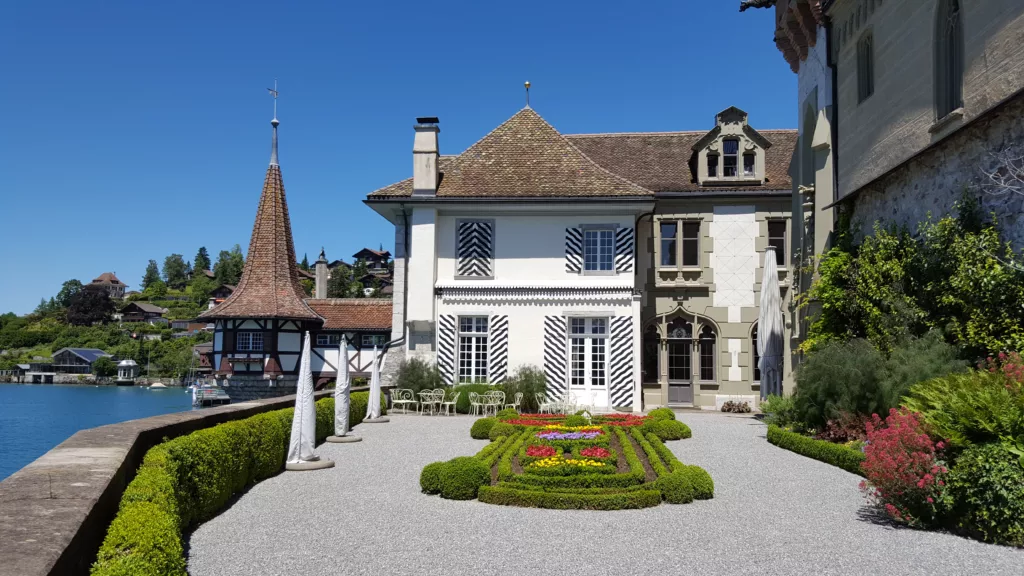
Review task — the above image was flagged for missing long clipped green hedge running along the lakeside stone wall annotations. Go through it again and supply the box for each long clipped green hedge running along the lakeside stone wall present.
[91,392,386,576]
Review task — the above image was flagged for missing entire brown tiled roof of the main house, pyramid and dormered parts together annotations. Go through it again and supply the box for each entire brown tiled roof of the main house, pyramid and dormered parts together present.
[368,108,798,201]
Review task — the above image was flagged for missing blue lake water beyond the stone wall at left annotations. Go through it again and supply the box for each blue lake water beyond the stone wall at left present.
[0,384,193,480]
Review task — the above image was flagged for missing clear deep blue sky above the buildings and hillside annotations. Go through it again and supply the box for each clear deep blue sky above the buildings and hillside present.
[0,0,797,314]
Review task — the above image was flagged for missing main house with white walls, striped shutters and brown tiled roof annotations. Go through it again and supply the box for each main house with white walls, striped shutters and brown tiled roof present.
[366,107,804,411]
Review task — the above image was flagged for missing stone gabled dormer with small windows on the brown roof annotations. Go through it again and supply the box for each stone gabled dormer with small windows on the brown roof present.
[693,106,771,186]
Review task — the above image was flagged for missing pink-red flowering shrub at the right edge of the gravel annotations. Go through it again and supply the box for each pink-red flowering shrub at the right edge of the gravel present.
[860,409,949,526]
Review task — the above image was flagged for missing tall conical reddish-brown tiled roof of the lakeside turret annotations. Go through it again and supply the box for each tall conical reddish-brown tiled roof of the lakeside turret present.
[200,162,321,320]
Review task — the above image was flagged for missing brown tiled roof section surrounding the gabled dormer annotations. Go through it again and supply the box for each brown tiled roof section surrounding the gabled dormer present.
[565,130,797,193]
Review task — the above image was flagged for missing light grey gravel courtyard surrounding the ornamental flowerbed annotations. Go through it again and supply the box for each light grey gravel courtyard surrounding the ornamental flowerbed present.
[188,413,1024,576]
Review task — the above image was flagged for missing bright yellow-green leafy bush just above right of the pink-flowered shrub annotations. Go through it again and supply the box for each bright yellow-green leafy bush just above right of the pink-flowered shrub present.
[904,371,1024,450]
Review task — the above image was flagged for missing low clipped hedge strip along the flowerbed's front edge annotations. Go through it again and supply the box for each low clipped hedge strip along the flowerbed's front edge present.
[479,486,662,510]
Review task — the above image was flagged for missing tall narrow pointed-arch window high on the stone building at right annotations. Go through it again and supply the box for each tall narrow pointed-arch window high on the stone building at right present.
[935,0,964,119]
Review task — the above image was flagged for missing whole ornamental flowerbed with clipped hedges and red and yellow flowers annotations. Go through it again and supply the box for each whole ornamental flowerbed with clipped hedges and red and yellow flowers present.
[420,410,715,510]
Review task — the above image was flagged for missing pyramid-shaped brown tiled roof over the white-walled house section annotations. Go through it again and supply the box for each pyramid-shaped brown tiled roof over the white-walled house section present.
[370,108,650,199]
